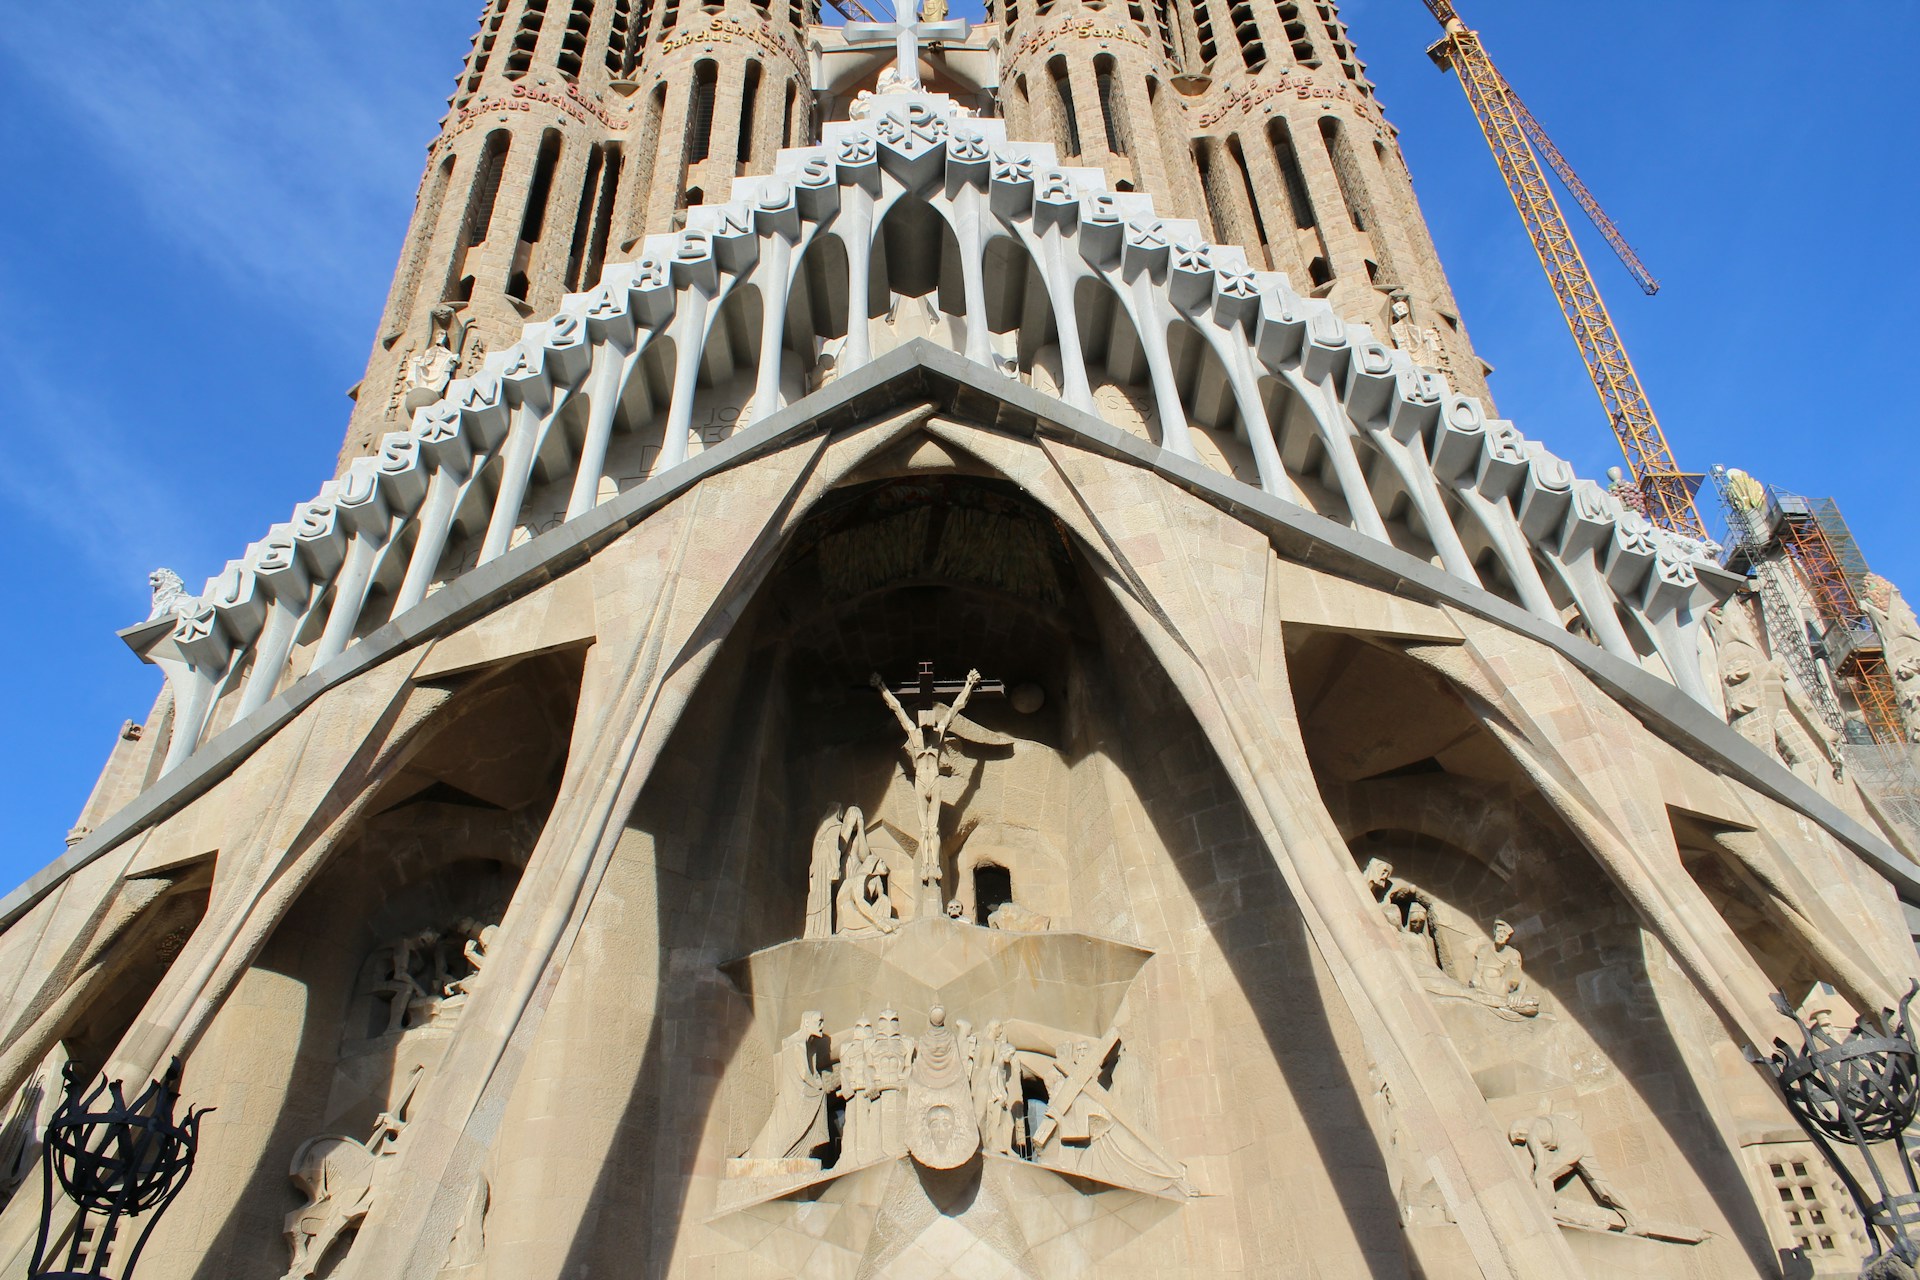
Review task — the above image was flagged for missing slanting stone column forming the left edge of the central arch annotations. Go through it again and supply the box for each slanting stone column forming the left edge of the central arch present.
[355,411,924,1280]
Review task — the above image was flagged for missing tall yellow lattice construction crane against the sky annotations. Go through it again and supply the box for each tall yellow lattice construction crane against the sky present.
[1425,0,1707,537]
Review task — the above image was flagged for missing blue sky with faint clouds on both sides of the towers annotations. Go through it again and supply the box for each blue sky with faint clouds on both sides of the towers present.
[0,0,1920,901]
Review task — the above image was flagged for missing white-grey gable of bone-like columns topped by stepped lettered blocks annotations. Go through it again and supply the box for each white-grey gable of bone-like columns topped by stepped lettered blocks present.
[136,94,1715,768]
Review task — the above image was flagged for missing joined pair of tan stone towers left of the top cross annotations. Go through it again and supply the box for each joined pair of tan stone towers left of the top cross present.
[340,0,818,466]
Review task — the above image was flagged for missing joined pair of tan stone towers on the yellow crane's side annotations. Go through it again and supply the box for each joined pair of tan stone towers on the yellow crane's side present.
[993,0,1486,399]
